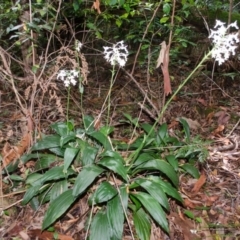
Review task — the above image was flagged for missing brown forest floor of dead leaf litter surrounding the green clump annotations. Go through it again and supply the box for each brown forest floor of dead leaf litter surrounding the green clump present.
[0,55,240,240]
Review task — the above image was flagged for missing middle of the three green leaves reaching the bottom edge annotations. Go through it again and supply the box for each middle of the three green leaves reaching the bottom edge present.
[107,195,124,239]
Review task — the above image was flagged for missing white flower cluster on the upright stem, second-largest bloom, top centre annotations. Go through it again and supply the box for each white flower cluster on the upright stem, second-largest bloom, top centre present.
[103,41,128,67]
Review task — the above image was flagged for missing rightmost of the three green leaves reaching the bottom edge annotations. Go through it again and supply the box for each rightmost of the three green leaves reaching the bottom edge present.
[133,208,151,240]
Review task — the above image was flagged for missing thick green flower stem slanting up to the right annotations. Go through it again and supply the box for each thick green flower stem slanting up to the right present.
[127,51,212,163]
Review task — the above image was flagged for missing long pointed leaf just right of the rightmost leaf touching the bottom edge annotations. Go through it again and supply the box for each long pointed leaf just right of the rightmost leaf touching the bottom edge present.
[133,192,169,233]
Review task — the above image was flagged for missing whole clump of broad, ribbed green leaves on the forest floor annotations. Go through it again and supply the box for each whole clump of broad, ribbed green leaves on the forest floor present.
[21,115,208,240]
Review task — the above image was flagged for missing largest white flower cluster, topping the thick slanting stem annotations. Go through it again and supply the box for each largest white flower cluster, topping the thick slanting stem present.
[209,20,239,65]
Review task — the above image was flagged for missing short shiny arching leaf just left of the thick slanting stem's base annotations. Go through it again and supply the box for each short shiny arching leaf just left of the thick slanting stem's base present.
[99,157,127,181]
